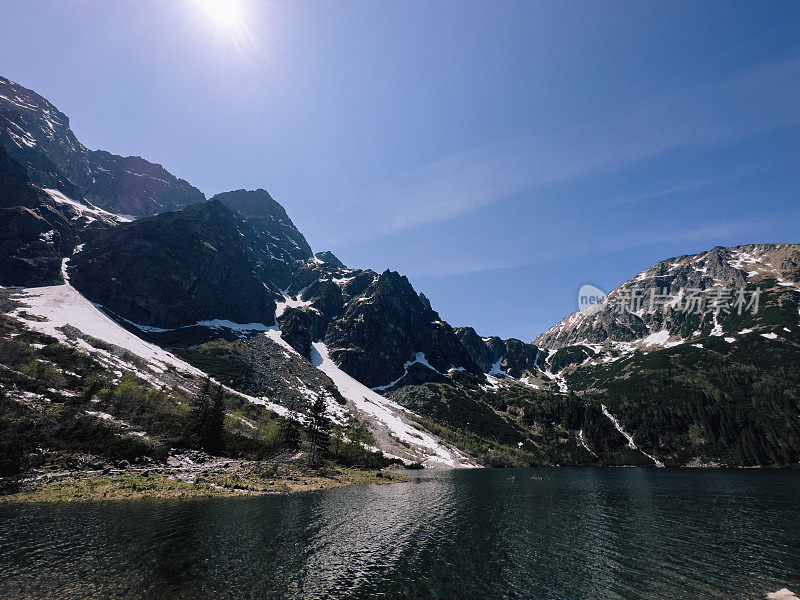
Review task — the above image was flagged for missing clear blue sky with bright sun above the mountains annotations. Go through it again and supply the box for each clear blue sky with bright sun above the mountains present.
[0,0,800,341]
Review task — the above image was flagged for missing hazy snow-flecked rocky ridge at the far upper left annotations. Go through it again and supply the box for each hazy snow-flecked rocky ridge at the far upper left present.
[0,77,205,216]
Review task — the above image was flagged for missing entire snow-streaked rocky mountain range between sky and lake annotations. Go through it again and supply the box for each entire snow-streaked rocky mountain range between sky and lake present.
[0,78,800,466]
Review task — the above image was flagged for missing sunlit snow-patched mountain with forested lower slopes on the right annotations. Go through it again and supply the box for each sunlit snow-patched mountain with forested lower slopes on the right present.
[390,244,800,465]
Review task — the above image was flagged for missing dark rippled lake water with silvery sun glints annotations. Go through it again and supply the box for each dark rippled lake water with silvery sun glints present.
[0,469,800,600]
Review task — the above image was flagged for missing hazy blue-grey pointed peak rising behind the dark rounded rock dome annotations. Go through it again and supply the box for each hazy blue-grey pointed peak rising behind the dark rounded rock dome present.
[213,189,313,289]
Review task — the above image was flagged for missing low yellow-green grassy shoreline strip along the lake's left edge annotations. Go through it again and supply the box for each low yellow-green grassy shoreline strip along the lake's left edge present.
[0,467,409,504]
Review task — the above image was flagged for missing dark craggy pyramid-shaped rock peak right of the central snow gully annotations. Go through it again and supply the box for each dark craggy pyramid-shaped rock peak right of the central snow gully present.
[325,271,480,387]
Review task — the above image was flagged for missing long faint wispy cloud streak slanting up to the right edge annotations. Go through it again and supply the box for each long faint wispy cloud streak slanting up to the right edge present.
[340,59,800,243]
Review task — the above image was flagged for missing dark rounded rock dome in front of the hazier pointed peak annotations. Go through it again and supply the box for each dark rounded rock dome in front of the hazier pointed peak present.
[72,201,275,327]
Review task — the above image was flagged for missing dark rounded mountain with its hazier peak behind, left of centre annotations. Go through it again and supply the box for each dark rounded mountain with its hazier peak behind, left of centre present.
[70,190,312,328]
